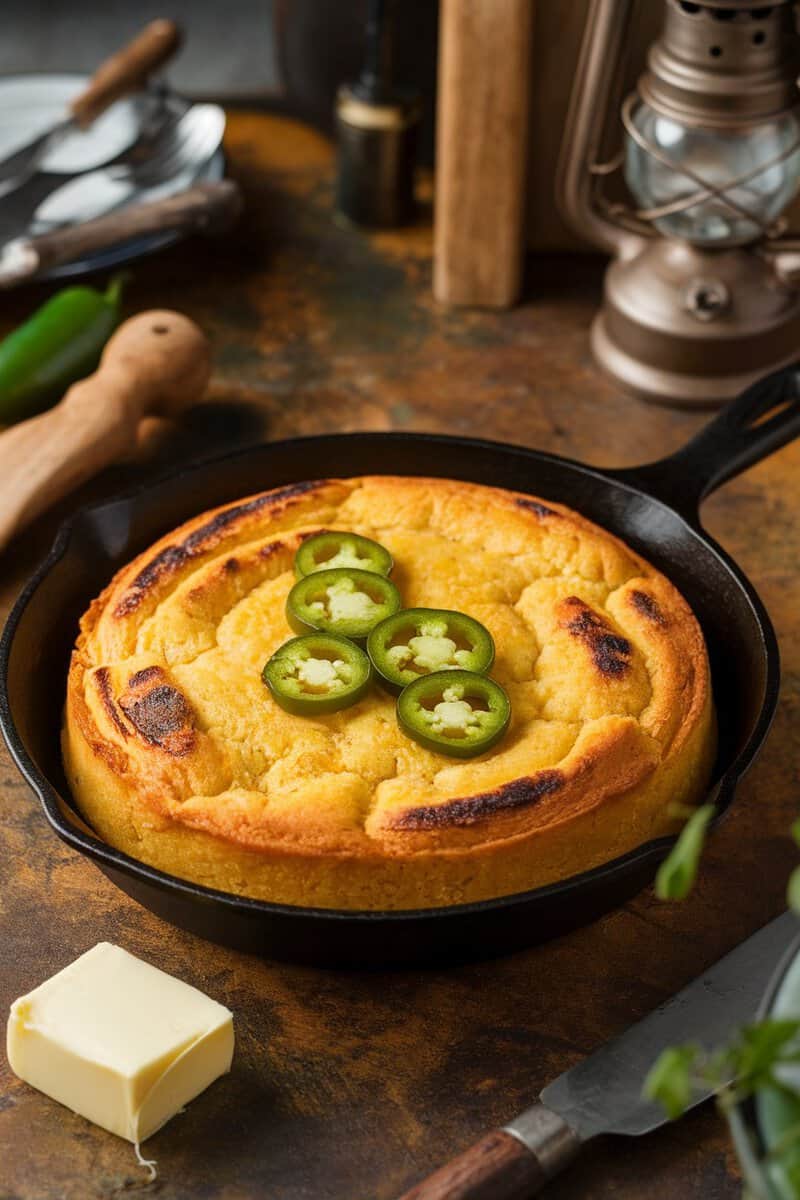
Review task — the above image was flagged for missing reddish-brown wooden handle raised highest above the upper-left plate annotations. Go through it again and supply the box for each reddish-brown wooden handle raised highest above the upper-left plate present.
[70,18,182,130]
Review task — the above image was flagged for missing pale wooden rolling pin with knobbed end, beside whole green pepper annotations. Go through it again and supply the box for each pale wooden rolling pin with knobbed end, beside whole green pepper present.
[0,310,211,550]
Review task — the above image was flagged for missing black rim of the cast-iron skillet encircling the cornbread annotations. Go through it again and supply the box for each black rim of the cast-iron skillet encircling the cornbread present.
[0,430,781,925]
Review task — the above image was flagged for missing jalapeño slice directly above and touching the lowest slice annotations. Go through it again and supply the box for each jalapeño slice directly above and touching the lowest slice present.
[367,608,494,694]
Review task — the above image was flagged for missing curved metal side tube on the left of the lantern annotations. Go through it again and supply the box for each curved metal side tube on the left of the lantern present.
[557,0,646,258]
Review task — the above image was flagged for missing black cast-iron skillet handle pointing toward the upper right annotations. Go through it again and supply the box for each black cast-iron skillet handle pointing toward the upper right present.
[613,360,800,524]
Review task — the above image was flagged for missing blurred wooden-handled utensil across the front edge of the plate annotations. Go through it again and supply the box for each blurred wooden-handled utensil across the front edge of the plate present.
[0,179,242,288]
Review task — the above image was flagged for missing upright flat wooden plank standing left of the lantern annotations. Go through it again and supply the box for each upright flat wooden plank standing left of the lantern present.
[433,0,534,308]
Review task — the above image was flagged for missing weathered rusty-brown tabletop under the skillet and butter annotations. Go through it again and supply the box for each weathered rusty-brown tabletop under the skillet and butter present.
[0,114,800,1200]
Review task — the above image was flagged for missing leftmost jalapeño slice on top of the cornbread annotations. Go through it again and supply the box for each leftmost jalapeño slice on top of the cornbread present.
[261,634,372,716]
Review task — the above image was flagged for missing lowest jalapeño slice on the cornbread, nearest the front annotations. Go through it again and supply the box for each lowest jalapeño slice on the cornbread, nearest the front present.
[397,671,511,758]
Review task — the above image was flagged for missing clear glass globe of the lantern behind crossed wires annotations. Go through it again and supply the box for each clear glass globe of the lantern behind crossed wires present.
[625,103,800,246]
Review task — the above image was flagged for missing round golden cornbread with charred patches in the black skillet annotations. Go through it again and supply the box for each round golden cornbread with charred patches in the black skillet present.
[64,476,715,910]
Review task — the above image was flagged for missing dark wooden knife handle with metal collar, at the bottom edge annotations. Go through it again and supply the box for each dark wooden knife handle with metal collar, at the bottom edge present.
[401,1104,581,1200]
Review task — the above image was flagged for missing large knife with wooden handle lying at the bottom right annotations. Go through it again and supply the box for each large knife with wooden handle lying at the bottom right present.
[402,912,800,1200]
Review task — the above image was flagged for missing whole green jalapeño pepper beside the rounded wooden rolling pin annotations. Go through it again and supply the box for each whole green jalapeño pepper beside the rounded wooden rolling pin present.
[0,276,122,425]
